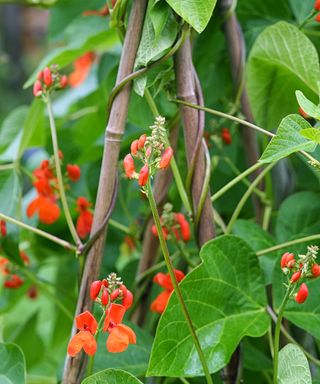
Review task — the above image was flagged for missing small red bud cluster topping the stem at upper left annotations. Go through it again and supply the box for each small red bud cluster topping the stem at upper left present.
[33,65,68,97]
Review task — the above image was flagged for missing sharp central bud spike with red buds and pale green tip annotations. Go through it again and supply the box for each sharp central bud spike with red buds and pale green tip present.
[123,116,173,193]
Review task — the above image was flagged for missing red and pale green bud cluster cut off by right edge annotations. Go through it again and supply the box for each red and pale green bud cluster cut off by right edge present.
[280,246,320,304]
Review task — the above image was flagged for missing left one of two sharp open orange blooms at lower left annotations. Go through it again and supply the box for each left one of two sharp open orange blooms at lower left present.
[68,311,98,356]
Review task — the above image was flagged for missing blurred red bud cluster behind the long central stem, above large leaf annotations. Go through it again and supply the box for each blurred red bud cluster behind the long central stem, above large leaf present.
[151,203,191,242]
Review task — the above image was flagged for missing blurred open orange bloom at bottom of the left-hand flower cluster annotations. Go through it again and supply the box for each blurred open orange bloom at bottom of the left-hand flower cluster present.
[27,195,60,224]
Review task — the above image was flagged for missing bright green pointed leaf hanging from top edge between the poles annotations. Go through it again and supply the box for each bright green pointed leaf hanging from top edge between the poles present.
[166,0,217,33]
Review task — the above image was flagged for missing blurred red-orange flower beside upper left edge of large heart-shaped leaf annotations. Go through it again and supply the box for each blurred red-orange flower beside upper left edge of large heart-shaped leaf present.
[150,269,185,313]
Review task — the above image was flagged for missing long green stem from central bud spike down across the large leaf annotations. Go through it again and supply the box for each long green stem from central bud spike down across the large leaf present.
[147,180,213,384]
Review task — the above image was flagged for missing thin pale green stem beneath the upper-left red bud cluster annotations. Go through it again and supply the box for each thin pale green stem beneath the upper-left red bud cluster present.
[47,95,82,246]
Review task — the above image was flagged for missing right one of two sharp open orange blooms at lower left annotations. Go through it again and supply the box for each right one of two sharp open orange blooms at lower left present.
[103,304,136,353]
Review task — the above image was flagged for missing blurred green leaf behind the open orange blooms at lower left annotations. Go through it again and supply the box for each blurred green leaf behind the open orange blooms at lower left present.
[94,324,153,376]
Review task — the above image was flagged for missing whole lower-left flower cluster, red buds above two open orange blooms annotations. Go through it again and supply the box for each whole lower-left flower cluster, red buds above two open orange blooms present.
[68,273,136,356]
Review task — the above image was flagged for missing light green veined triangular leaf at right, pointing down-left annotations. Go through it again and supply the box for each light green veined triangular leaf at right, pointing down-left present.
[260,115,316,163]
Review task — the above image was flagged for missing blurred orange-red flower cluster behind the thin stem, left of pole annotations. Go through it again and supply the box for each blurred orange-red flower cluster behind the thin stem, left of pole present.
[27,151,84,231]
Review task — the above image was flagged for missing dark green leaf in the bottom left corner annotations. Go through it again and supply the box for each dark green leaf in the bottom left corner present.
[0,343,26,384]
